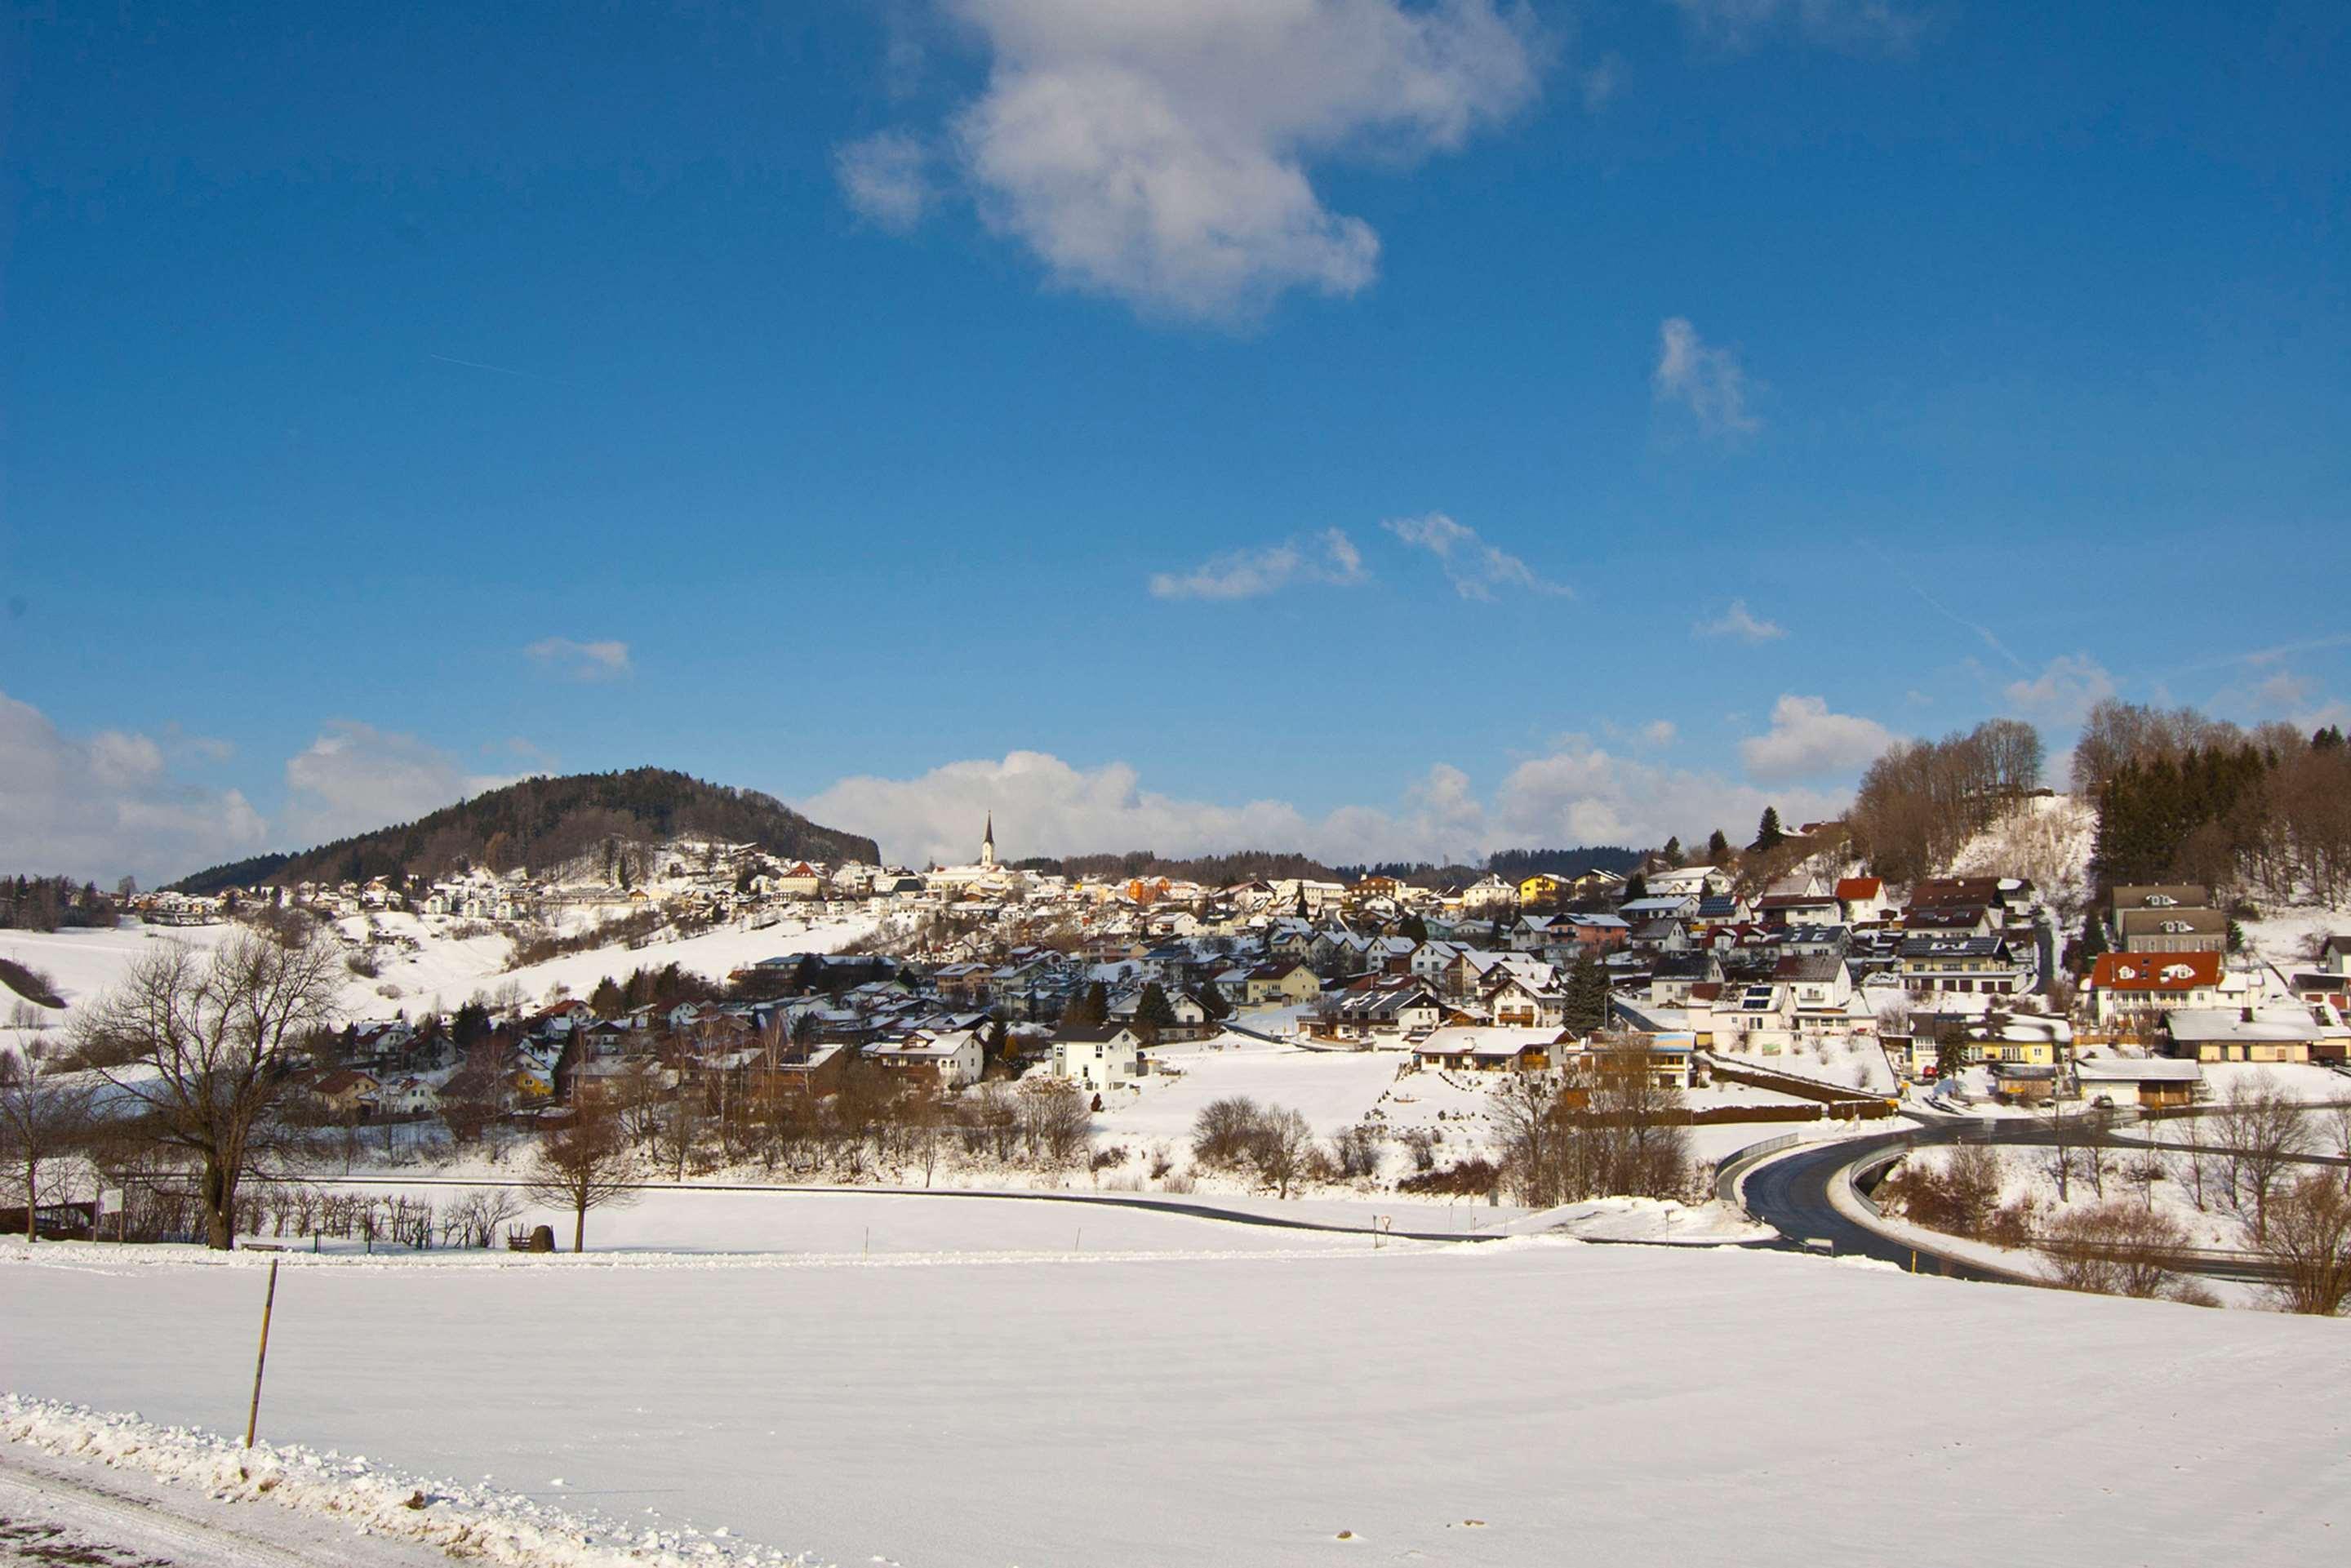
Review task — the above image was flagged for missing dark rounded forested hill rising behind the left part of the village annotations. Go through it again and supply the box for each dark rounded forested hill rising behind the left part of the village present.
[174,769,882,893]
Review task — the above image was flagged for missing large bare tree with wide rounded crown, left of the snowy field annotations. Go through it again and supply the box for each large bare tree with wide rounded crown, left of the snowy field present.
[75,929,343,1250]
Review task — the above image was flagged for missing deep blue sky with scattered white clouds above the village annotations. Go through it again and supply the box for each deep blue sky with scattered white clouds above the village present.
[0,0,2351,879]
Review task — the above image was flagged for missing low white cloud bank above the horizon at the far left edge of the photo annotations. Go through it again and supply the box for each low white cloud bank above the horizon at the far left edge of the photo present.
[0,691,268,884]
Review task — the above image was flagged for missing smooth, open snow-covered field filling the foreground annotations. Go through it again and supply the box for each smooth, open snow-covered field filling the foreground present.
[0,1206,2351,1568]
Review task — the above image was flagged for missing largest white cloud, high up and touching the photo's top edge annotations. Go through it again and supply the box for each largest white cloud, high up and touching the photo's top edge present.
[864,0,1544,322]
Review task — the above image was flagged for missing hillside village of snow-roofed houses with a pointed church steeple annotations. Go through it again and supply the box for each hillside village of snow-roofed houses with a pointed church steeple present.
[100,820,2351,1175]
